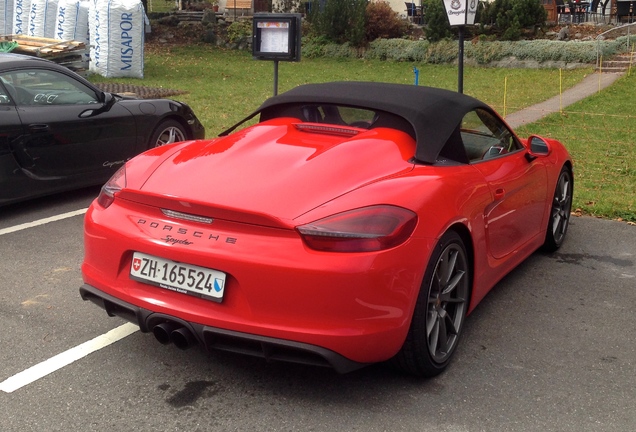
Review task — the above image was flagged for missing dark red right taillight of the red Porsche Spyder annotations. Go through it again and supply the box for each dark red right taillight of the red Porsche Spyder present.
[296,205,417,252]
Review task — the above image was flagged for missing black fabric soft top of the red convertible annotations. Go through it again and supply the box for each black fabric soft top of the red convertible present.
[221,81,492,164]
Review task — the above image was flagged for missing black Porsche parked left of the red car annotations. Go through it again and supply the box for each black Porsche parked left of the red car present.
[0,53,205,205]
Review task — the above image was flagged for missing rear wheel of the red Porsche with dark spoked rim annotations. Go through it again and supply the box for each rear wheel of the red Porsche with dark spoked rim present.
[393,231,471,377]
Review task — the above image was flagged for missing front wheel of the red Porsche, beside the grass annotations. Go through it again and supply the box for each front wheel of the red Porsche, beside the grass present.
[543,167,574,252]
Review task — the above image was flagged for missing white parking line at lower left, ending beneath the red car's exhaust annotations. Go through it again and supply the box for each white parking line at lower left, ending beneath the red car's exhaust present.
[0,323,139,393]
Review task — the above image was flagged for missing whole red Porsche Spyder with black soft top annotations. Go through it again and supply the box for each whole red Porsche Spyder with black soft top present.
[80,82,573,376]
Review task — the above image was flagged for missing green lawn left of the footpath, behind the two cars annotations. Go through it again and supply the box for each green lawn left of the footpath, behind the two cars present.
[91,45,590,133]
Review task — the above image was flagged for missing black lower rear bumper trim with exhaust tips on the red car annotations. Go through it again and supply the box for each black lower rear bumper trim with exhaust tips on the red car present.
[80,284,366,373]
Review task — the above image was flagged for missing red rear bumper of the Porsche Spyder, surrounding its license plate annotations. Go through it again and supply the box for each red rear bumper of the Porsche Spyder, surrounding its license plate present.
[82,199,432,371]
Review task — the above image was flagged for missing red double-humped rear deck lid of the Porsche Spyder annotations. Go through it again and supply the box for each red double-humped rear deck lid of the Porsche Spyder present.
[141,120,415,224]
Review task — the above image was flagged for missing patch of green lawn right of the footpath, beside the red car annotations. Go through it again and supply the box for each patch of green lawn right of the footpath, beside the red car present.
[519,75,636,222]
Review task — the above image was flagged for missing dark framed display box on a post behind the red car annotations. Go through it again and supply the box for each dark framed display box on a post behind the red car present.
[252,13,301,96]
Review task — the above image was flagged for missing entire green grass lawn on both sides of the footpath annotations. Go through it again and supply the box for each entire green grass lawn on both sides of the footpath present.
[90,45,636,221]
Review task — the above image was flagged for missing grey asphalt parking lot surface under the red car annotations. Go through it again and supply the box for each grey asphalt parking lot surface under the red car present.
[0,189,636,432]
